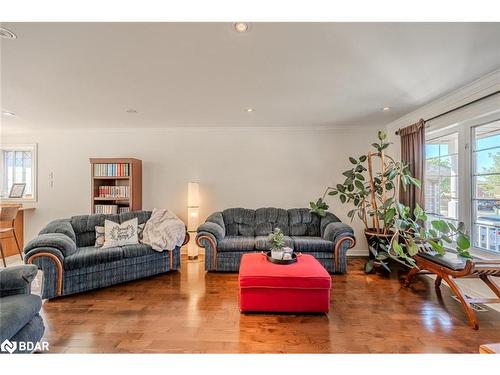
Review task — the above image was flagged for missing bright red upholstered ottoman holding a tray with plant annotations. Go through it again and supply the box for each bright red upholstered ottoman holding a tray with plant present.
[239,253,332,313]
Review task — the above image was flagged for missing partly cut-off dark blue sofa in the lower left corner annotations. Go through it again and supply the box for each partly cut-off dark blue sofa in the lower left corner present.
[0,265,45,354]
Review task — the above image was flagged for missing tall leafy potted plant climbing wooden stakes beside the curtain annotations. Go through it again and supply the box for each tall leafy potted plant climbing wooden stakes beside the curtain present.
[311,131,470,273]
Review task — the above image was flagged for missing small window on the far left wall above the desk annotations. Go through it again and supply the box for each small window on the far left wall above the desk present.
[0,145,36,200]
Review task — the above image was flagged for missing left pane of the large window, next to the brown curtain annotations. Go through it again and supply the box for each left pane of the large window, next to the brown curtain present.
[424,132,459,228]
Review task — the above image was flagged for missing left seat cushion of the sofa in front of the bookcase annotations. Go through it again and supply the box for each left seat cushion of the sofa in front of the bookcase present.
[64,246,123,270]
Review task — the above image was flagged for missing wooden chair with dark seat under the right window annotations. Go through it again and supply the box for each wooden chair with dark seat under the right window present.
[405,252,500,329]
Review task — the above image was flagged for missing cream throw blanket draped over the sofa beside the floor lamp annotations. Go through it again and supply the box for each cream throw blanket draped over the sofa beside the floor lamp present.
[142,208,186,252]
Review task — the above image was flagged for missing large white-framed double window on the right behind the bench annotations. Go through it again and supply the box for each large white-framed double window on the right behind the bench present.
[424,117,500,256]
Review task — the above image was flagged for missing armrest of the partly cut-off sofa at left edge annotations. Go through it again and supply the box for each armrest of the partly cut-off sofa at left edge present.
[0,265,38,297]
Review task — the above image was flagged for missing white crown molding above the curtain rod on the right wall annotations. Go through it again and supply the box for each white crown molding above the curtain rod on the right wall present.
[386,69,500,132]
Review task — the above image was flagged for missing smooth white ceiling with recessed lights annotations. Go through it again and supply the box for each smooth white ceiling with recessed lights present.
[1,23,500,129]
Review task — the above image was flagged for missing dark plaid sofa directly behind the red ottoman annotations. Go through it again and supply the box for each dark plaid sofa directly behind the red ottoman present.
[196,207,355,273]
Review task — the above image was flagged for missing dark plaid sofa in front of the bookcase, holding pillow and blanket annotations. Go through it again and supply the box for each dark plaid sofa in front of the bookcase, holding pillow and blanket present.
[24,211,189,298]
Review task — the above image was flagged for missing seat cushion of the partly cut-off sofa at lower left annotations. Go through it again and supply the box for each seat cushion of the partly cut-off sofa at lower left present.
[0,294,42,342]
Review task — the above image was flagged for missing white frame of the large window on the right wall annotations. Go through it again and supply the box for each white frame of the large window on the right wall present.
[424,111,500,259]
